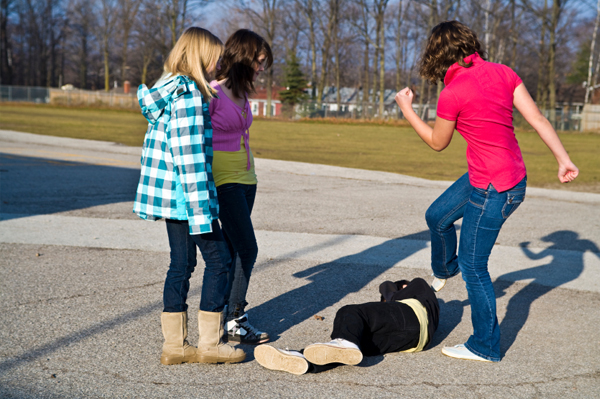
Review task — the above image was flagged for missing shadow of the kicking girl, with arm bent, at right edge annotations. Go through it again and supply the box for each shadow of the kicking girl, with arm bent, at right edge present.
[494,230,600,353]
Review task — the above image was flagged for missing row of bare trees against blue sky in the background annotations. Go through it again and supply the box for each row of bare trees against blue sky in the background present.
[0,0,600,118]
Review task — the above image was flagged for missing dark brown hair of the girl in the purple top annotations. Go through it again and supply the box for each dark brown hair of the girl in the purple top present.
[217,29,273,98]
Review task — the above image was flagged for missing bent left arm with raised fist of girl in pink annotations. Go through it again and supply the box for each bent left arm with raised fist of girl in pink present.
[395,87,456,151]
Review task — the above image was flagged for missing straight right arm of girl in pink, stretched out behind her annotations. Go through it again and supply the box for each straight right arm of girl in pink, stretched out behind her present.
[513,83,579,183]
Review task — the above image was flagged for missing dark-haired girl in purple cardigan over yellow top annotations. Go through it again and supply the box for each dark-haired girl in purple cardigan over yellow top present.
[209,29,273,344]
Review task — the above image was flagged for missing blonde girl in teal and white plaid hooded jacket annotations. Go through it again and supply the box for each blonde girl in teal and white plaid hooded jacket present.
[133,27,246,364]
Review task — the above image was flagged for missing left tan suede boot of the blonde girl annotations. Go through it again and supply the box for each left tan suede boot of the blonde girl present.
[160,312,198,364]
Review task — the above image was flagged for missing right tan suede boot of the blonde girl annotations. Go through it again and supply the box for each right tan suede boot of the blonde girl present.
[198,310,246,363]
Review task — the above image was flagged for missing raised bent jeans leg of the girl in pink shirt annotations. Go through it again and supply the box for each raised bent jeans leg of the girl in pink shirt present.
[425,173,473,279]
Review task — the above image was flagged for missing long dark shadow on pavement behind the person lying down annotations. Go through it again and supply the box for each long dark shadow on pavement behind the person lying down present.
[246,232,427,340]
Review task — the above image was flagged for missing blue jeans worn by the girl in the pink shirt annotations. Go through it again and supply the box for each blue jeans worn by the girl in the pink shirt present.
[425,173,527,362]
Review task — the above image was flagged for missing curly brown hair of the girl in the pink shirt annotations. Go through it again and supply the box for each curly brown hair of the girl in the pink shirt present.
[419,21,486,84]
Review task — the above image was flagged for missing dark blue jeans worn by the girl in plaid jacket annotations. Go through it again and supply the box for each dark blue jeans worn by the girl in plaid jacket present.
[163,219,231,312]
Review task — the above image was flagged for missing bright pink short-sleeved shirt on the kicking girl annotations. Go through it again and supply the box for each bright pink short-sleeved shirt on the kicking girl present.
[437,53,527,192]
